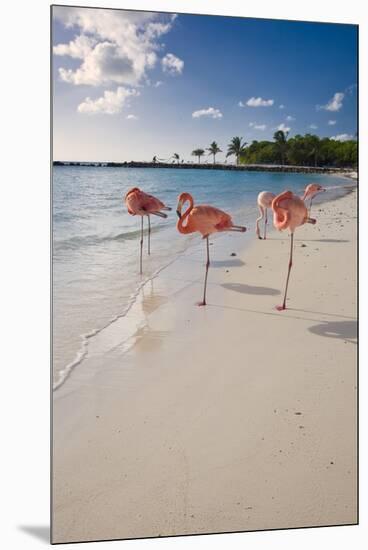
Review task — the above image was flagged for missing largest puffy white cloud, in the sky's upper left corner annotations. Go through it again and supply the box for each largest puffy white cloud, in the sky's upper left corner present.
[53,6,175,86]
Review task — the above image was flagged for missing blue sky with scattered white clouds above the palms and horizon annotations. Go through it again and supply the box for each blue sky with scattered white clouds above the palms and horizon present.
[53,7,357,161]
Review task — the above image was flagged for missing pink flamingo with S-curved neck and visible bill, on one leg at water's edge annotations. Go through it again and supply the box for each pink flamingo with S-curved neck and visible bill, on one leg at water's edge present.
[176,193,246,306]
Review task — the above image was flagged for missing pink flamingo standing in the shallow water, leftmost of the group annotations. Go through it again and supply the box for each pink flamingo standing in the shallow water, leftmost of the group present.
[125,187,171,274]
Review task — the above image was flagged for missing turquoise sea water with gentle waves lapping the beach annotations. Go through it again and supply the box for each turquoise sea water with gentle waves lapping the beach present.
[53,166,350,387]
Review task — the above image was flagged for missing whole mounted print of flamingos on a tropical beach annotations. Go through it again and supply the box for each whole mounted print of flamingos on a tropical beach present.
[51,6,358,543]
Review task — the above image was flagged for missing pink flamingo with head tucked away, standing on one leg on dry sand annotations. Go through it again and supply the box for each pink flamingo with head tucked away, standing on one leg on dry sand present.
[272,191,316,311]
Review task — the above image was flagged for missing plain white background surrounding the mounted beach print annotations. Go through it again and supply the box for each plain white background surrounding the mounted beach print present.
[0,0,368,550]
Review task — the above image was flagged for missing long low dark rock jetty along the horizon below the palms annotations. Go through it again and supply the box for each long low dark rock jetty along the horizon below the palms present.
[53,160,353,175]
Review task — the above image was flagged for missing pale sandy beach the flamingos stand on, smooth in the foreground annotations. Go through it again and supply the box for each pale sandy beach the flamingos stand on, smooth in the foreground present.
[52,191,357,542]
